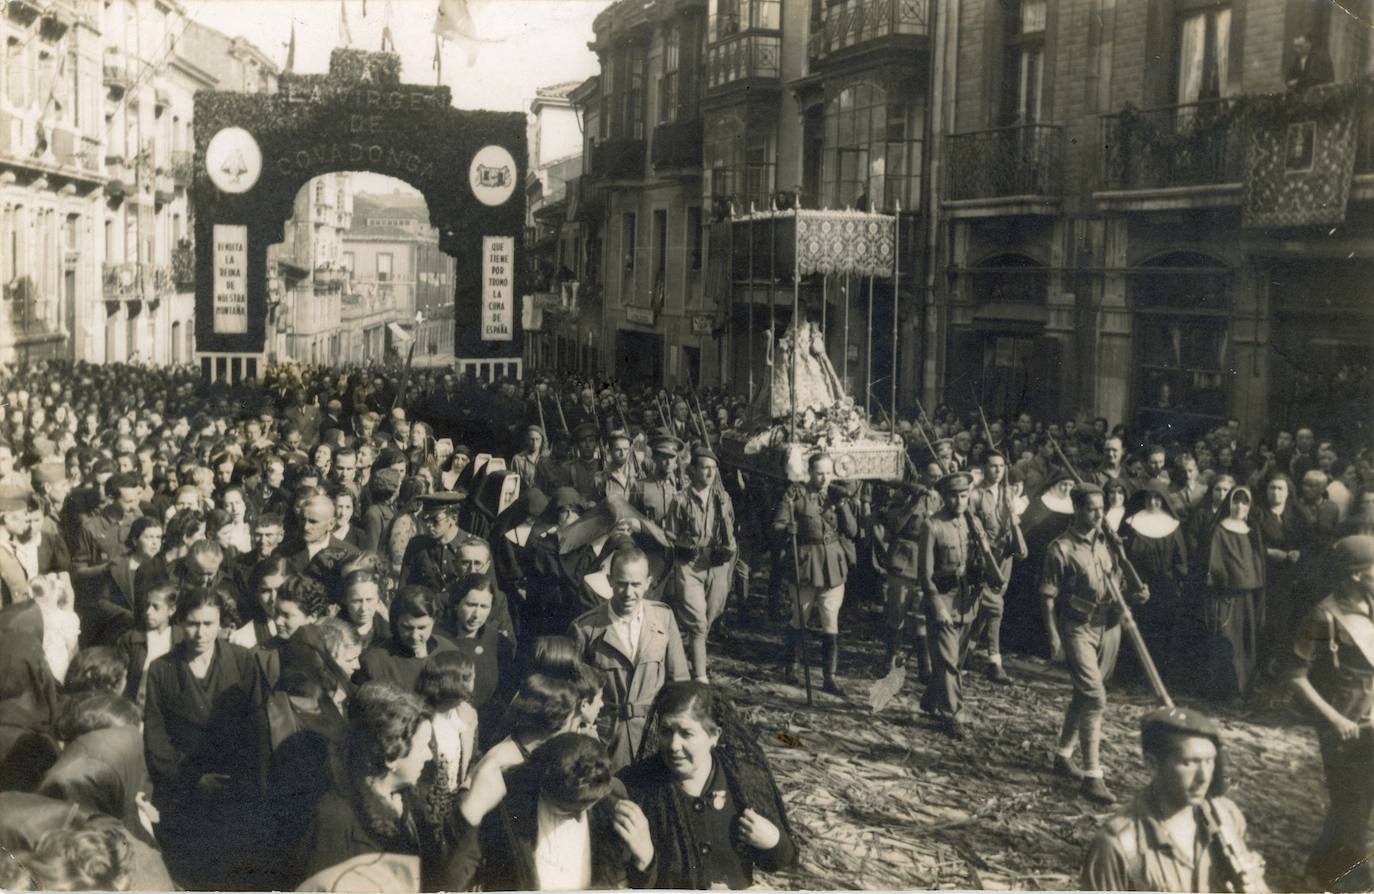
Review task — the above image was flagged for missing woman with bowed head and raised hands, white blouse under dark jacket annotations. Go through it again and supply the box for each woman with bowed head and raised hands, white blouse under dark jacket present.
[441,732,654,891]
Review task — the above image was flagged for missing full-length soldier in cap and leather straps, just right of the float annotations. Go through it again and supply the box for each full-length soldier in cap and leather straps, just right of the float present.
[916,472,982,739]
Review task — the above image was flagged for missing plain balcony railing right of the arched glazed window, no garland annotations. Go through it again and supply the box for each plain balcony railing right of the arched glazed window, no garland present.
[945,124,1063,199]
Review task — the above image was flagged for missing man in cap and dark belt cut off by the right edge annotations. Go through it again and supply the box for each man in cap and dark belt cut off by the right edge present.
[1287,534,1374,891]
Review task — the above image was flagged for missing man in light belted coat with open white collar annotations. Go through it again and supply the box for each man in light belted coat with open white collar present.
[567,547,691,770]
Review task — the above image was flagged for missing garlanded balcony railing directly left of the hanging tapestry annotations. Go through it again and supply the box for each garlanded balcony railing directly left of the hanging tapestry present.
[1102,99,1246,190]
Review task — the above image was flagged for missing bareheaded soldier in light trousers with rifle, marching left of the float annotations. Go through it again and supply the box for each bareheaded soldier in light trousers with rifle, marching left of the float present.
[664,446,738,683]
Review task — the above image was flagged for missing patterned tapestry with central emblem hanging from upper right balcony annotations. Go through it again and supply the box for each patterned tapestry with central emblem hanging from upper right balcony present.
[1241,81,1370,228]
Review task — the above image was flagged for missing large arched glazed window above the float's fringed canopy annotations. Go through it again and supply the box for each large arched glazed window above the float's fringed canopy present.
[822,82,925,211]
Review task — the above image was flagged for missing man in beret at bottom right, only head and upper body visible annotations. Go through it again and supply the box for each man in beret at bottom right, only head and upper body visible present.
[1080,707,1268,893]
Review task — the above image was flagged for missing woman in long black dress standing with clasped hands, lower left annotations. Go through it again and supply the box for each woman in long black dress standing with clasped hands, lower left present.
[143,589,262,889]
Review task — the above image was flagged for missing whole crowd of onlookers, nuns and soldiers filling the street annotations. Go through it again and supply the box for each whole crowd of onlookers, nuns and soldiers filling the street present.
[0,363,1374,890]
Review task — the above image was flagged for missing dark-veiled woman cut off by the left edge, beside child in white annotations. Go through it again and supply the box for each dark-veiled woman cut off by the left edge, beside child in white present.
[0,601,59,791]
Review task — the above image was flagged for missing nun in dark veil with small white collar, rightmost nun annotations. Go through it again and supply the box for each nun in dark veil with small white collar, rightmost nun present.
[1202,488,1265,703]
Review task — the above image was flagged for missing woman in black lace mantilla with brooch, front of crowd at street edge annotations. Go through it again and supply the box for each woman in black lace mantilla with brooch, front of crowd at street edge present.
[620,681,797,890]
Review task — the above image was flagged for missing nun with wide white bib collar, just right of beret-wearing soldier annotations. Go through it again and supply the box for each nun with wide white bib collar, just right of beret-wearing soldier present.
[1120,481,1189,677]
